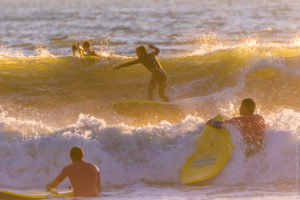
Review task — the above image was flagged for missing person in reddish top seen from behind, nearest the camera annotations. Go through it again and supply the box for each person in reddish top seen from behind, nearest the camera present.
[46,146,101,197]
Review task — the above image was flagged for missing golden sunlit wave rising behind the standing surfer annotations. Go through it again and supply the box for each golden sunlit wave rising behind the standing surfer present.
[0,46,300,124]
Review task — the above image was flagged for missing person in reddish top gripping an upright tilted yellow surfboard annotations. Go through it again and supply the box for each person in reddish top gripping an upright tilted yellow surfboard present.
[207,98,266,157]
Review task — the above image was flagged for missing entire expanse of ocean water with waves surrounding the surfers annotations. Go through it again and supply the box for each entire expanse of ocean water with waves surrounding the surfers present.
[0,0,300,200]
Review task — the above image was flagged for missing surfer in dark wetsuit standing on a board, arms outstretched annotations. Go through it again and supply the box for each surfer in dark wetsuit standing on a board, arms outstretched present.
[115,44,170,102]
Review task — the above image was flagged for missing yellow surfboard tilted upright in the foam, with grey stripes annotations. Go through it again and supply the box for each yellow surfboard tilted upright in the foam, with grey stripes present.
[180,115,234,184]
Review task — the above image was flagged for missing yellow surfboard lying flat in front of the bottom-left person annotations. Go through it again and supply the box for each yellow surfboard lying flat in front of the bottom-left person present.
[0,190,73,200]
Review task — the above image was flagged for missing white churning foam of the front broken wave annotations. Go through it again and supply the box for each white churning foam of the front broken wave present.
[0,110,300,188]
